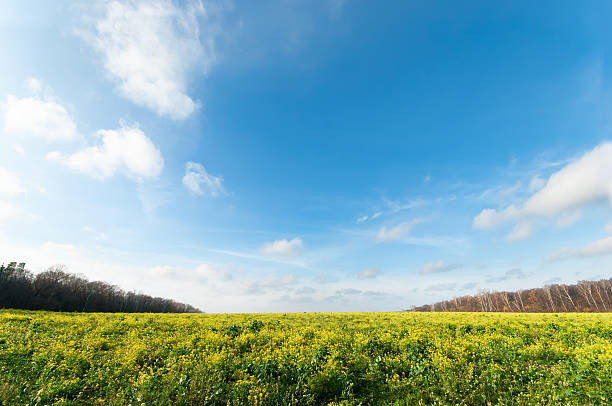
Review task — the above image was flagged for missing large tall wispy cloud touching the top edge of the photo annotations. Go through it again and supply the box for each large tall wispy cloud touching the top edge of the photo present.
[84,0,218,120]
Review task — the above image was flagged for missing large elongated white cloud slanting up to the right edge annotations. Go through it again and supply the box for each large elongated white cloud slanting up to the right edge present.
[473,142,612,237]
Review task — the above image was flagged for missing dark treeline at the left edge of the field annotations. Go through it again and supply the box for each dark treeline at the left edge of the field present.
[0,262,201,313]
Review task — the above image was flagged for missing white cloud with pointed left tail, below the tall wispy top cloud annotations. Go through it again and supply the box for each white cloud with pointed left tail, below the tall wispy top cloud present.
[47,124,164,181]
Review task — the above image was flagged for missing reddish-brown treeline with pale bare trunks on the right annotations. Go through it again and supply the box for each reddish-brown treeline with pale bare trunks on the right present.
[410,279,612,313]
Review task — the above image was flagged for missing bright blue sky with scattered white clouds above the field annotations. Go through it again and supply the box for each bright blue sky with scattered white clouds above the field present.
[0,0,612,312]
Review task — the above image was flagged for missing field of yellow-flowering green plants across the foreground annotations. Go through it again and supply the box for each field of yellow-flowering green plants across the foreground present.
[0,310,612,405]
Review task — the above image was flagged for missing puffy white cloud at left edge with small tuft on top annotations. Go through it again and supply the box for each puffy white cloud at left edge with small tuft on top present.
[2,79,78,141]
